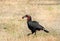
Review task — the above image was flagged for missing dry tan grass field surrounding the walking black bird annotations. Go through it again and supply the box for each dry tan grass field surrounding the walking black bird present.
[0,0,60,41]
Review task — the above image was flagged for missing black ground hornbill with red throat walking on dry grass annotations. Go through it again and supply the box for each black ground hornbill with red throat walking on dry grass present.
[22,15,49,36]
